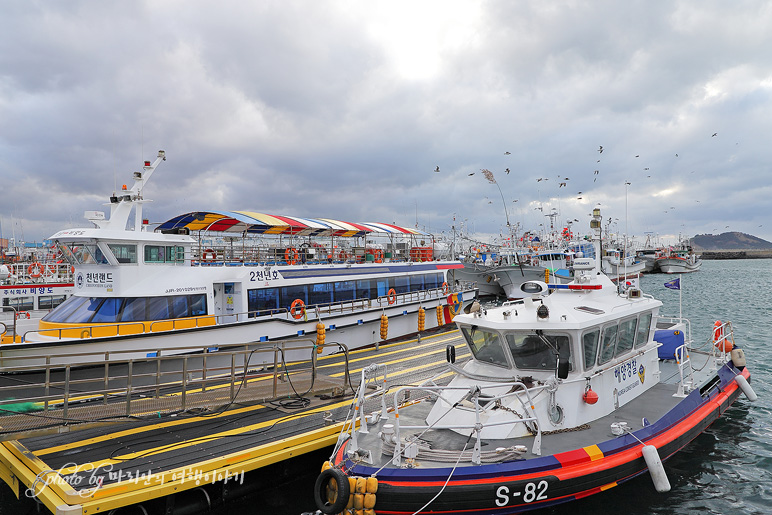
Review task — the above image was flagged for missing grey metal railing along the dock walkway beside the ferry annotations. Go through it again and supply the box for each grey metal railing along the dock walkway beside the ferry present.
[0,339,350,440]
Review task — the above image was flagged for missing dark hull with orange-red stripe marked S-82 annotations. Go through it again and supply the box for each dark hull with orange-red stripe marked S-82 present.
[335,366,750,515]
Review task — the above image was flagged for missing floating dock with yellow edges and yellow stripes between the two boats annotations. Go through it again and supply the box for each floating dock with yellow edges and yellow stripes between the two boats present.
[0,331,468,514]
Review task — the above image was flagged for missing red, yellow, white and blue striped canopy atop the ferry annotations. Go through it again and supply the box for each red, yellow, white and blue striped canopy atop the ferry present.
[156,211,428,237]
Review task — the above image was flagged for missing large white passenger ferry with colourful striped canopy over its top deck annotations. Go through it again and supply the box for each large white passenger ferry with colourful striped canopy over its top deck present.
[0,151,476,365]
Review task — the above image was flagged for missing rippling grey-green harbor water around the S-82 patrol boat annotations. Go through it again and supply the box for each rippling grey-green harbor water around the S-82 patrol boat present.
[0,259,772,515]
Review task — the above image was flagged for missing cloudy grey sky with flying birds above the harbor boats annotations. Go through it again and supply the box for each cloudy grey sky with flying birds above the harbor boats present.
[0,0,772,249]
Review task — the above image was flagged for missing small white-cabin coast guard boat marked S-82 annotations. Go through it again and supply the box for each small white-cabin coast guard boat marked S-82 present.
[314,209,756,515]
